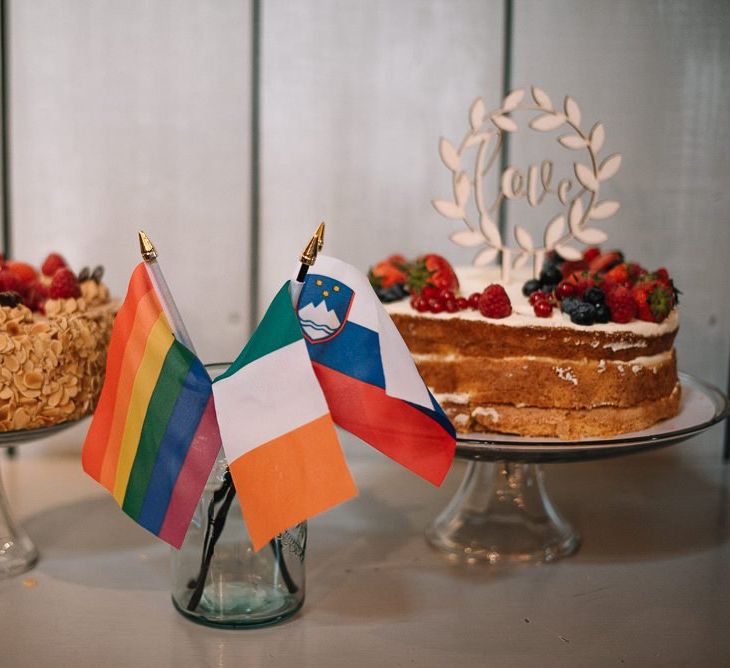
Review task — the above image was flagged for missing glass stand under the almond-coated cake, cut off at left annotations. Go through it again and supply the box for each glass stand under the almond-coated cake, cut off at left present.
[0,420,78,579]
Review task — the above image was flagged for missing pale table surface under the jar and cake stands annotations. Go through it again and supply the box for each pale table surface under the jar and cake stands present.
[0,424,730,668]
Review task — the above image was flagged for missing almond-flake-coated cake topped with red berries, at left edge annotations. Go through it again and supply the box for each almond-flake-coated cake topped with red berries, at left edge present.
[0,253,116,431]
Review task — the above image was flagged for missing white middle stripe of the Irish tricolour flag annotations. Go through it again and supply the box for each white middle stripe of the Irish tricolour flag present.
[213,339,329,462]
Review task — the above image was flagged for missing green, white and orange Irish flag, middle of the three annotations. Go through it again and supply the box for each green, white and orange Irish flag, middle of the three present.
[213,283,357,549]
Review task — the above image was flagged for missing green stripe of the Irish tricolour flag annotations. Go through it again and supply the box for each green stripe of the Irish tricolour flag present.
[213,281,304,383]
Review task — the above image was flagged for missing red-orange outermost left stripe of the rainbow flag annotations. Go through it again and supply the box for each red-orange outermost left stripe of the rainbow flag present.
[82,263,153,480]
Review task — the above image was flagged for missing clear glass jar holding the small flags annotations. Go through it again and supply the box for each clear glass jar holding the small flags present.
[171,367,307,627]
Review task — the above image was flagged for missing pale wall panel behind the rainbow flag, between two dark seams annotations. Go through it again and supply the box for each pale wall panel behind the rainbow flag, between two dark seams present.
[8,0,251,361]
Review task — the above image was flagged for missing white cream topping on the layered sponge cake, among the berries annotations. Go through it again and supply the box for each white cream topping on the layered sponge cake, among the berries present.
[385,267,679,336]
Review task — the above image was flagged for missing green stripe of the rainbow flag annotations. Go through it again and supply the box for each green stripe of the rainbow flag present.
[122,345,195,519]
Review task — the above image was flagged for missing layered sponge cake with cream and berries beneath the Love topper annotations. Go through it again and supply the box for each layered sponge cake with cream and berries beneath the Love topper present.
[378,247,681,440]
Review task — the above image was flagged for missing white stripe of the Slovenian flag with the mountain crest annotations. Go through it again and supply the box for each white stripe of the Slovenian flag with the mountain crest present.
[302,255,433,409]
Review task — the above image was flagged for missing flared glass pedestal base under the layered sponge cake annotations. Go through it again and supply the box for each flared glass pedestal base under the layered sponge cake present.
[426,461,580,564]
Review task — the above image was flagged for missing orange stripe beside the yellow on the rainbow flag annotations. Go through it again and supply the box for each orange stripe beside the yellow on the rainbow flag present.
[99,290,164,493]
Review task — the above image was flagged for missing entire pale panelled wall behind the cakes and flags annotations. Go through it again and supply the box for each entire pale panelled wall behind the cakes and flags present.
[6,0,730,438]
